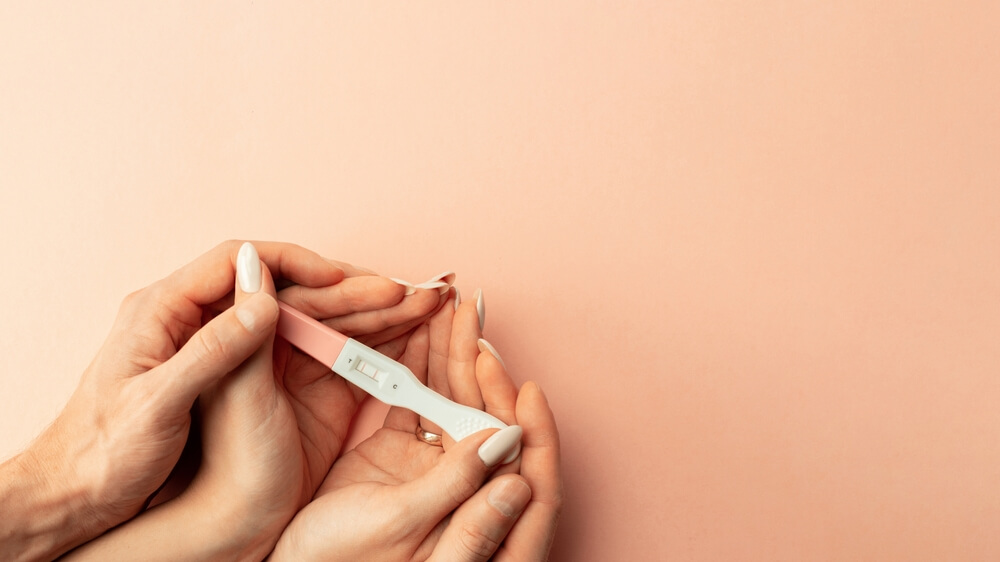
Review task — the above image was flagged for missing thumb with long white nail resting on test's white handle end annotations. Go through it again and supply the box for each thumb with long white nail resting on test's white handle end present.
[405,425,522,527]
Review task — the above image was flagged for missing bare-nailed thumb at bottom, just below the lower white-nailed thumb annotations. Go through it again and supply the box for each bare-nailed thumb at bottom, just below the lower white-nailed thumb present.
[429,474,531,562]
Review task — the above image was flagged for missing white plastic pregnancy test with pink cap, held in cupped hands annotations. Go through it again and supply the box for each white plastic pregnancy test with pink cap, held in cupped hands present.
[278,302,520,456]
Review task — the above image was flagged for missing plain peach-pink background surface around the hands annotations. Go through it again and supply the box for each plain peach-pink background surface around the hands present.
[0,0,1000,561]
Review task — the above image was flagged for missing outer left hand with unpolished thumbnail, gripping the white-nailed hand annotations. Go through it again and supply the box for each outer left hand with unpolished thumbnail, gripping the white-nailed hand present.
[0,238,344,558]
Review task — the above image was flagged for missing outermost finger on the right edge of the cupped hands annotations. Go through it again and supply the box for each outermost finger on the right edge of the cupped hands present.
[495,382,564,562]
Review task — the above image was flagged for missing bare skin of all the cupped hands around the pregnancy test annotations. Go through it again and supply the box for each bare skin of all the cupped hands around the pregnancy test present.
[0,238,562,560]
